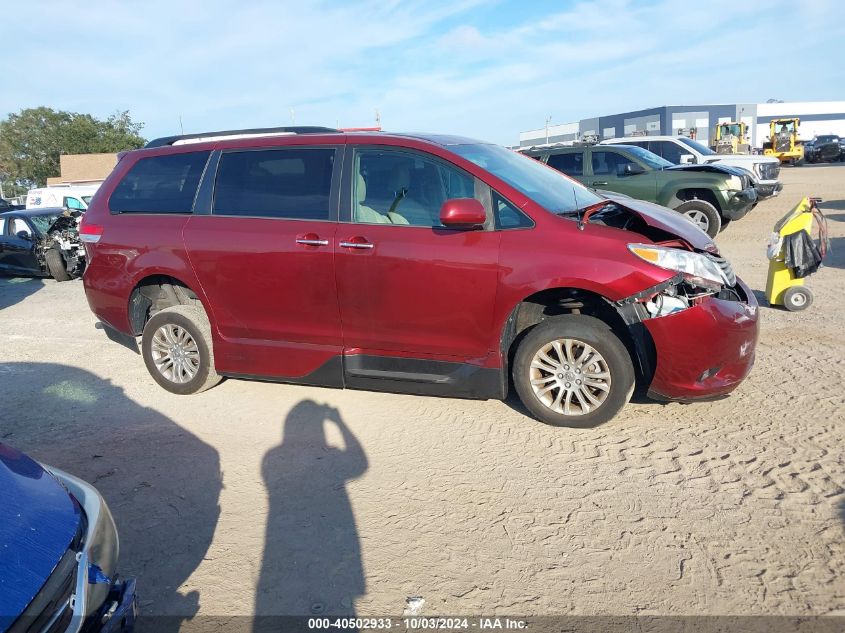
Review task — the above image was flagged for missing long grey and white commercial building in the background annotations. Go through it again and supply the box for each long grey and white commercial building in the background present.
[519,101,845,148]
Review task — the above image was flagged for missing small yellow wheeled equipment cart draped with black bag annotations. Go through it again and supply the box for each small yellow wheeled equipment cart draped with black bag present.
[766,198,828,312]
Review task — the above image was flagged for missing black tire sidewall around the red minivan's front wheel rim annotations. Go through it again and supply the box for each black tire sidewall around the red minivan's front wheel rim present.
[512,315,635,428]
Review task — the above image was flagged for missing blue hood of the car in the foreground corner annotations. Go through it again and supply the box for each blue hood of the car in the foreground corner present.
[0,444,82,631]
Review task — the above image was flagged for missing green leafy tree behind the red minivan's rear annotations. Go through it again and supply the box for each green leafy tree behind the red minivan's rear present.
[0,107,145,186]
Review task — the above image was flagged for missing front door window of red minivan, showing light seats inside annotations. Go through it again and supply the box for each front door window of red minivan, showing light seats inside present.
[352,149,475,227]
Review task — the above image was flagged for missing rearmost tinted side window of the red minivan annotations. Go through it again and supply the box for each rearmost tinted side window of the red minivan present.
[109,152,210,213]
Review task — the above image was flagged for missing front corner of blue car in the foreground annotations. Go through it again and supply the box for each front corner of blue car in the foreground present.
[0,444,137,633]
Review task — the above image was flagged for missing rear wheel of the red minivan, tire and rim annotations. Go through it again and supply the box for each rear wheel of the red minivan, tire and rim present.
[141,305,221,395]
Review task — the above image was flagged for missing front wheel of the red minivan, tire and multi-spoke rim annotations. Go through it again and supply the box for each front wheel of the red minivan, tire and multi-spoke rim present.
[513,315,634,427]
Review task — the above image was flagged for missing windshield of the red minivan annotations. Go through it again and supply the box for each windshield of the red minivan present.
[449,145,604,215]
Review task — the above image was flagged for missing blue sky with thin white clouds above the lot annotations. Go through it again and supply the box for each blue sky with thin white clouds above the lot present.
[0,0,845,144]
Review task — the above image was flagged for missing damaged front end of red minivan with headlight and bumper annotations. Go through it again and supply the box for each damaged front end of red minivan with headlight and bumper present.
[585,196,758,401]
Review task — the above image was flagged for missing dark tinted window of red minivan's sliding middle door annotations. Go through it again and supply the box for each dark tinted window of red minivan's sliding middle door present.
[213,148,335,220]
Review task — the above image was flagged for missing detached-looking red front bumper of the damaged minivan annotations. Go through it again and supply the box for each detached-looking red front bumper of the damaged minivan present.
[644,281,759,401]
